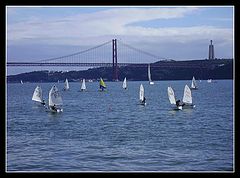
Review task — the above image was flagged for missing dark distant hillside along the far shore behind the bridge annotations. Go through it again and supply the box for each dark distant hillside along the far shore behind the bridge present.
[7,59,233,82]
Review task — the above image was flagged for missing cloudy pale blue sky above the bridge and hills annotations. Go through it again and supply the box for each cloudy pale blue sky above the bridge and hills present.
[6,6,234,75]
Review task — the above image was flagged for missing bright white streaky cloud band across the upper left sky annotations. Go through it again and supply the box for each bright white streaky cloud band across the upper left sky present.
[7,7,201,44]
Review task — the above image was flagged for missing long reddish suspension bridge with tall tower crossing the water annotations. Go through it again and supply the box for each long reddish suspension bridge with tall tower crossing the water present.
[7,39,225,80]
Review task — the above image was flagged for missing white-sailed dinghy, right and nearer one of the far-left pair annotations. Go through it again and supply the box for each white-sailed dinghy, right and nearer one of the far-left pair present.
[48,85,63,112]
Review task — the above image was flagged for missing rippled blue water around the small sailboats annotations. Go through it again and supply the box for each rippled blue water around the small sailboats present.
[6,80,234,172]
